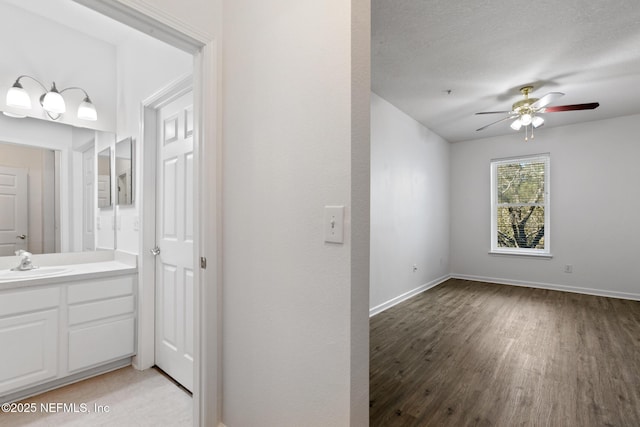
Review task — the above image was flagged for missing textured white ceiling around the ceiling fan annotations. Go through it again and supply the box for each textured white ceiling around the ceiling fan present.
[371,0,640,142]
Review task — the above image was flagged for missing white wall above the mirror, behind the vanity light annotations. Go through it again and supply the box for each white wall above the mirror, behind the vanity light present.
[0,2,116,132]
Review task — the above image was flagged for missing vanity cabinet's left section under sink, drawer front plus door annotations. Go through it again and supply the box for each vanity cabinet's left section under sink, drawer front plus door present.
[0,288,60,395]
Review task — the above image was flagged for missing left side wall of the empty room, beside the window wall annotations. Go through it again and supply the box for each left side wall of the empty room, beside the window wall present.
[369,94,450,314]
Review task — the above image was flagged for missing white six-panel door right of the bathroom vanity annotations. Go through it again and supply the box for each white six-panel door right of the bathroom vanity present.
[156,92,194,390]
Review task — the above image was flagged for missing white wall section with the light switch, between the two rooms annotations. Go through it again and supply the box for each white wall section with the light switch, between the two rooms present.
[221,0,370,427]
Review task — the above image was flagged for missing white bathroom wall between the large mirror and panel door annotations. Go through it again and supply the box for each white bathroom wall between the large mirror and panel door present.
[116,33,193,253]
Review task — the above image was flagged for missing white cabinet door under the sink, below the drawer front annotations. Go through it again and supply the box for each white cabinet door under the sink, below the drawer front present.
[0,309,58,395]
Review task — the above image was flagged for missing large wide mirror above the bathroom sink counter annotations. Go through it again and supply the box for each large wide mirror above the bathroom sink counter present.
[0,114,116,256]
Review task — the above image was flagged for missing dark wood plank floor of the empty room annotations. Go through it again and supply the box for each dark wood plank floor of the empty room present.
[369,279,640,427]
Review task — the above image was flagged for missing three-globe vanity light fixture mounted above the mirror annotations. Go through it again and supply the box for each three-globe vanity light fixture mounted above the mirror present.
[4,74,98,121]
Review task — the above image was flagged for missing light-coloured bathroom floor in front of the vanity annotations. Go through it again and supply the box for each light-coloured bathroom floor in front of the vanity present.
[0,367,193,427]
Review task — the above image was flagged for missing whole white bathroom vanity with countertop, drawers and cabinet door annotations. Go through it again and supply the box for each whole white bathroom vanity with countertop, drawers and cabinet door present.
[0,251,137,403]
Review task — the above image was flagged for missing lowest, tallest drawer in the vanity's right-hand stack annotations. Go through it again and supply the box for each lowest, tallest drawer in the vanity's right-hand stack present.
[68,317,135,372]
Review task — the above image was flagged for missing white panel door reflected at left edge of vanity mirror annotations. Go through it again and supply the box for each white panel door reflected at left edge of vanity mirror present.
[0,167,29,256]
